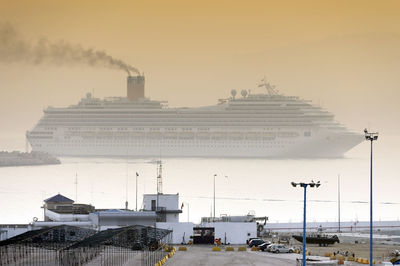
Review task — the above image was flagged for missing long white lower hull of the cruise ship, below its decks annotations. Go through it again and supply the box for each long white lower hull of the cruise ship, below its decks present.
[28,129,362,158]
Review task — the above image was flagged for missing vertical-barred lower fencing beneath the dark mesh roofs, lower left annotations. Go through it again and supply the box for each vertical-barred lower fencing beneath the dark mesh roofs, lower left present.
[0,245,168,266]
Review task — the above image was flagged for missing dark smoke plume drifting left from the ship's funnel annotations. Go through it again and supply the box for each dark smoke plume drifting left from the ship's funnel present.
[0,24,140,75]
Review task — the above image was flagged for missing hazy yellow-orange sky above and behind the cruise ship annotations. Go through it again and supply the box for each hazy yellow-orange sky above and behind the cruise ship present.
[0,0,400,149]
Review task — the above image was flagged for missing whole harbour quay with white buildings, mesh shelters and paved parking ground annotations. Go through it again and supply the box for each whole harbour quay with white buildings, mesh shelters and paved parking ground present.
[0,193,400,265]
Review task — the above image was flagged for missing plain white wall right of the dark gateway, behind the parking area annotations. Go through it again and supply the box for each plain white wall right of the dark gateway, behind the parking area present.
[201,222,257,244]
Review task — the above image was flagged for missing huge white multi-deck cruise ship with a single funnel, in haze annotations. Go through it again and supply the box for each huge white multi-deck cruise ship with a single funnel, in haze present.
[26,76,363,158]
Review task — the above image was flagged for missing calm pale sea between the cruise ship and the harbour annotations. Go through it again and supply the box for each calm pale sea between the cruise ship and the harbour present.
[0,136,400,224]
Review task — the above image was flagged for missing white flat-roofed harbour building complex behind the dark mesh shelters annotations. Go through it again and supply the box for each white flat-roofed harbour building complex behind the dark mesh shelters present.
[0,193,258,244]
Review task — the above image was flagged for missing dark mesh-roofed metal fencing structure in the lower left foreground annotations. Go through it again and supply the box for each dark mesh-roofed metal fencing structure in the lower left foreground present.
[0,225,172,266]
